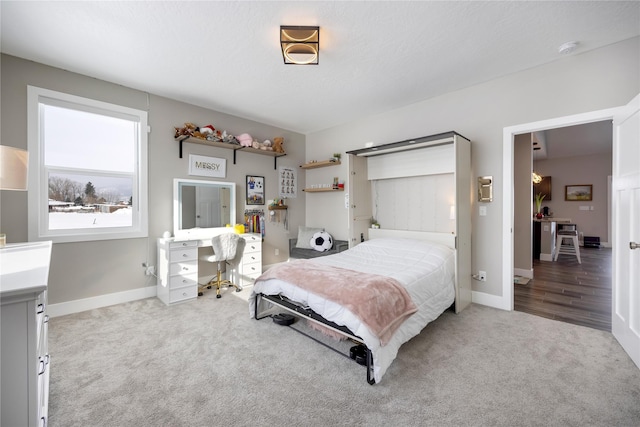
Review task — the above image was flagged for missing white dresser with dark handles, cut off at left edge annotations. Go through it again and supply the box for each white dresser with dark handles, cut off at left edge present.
[0,242,52,426]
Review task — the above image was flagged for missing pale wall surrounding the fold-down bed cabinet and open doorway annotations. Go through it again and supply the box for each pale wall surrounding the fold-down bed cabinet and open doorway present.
[306,38,640,304]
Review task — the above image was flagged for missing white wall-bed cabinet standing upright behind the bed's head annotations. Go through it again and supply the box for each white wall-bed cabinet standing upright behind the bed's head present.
[347,132,472,313]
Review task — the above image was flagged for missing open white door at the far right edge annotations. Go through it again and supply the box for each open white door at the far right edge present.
[612,95,640,367]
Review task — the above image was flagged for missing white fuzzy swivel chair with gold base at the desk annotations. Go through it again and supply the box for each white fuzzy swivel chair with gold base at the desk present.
[198,233,245,298]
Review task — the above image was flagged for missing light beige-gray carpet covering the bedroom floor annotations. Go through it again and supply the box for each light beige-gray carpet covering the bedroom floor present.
[48,293,640,427]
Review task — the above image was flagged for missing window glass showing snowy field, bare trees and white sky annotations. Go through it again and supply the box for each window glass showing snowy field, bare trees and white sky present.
[43,105,137,230]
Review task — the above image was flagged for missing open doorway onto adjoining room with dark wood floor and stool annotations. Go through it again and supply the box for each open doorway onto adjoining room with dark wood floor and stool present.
[514,120,613,332]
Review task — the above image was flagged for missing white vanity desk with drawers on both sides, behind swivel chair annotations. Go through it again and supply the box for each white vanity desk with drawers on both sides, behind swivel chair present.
[156,229,262,305]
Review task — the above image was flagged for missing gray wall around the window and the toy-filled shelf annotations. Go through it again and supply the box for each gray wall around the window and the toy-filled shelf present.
[0,55,305,304]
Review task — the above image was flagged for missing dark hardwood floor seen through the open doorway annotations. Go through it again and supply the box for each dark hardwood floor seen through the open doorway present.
[513,248,611,332]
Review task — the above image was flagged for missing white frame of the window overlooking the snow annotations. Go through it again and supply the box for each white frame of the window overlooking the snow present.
[27,86,149,243]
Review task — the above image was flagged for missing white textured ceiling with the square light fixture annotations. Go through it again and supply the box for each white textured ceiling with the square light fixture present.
[0,0,640,134]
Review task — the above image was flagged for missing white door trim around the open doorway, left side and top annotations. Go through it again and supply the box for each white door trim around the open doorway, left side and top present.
[497,106,624,311]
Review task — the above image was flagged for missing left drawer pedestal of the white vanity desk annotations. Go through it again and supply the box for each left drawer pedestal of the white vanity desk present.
[156,239,198,305]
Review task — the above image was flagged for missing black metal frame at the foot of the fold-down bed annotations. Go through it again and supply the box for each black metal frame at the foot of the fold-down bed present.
[254,293,376,385]
